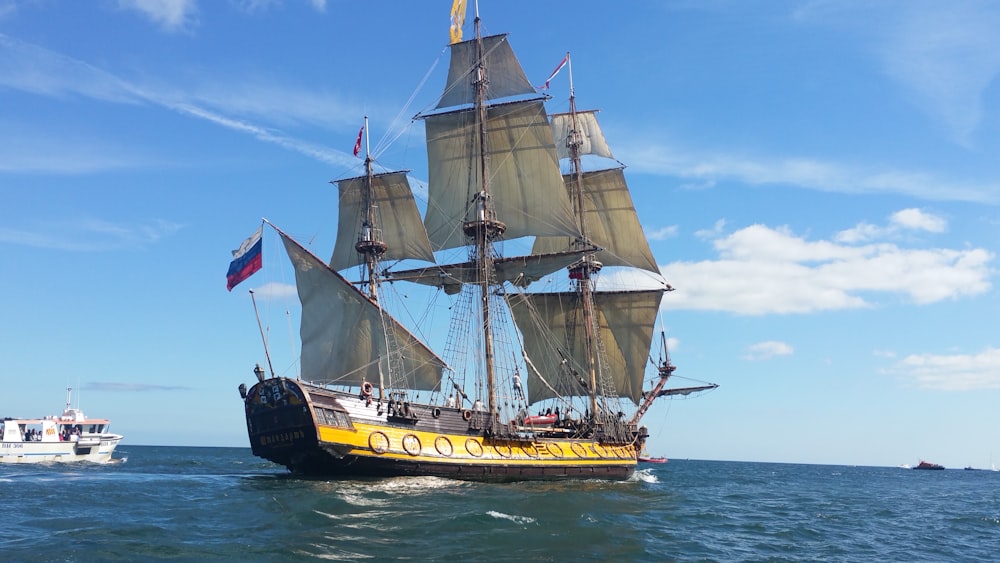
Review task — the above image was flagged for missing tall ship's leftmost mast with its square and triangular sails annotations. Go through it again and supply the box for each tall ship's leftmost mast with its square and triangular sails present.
[272,117,446,399]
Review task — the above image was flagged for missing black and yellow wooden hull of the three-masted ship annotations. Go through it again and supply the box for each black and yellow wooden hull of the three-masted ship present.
[238,378,638,481]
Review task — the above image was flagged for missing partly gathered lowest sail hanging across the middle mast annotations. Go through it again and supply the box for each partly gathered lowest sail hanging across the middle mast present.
[385,248,594,293]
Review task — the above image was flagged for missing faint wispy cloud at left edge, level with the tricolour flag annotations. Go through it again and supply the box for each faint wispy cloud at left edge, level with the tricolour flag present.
[0,219,183,252]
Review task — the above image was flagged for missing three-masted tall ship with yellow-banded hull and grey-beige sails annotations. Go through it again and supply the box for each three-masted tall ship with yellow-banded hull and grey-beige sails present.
[230,7,716,480]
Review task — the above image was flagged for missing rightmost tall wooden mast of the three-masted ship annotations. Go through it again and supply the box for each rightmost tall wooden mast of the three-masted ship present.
[566,52,601,417]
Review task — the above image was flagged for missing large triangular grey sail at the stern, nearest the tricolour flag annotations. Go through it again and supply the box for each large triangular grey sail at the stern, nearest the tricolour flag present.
[279,231,445,390]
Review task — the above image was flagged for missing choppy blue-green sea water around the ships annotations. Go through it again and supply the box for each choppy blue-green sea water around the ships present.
[0,445,1000,562]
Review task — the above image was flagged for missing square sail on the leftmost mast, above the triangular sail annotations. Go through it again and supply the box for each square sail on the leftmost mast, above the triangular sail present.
[330,171,434,270]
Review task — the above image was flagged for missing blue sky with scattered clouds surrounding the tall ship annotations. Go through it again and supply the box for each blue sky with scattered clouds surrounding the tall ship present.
[0,0,1000,467]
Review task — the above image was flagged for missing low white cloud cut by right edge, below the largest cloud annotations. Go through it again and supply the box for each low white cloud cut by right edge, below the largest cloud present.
[888,348,1000,391]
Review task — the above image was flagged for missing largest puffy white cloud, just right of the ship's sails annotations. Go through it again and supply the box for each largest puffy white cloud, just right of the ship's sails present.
[661,216,994,315]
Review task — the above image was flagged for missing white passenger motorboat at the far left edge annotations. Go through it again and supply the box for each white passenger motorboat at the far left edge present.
[0,388,122,463]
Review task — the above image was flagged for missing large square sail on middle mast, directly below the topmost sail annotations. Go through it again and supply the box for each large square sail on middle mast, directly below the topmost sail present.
[424,101,579,250]
